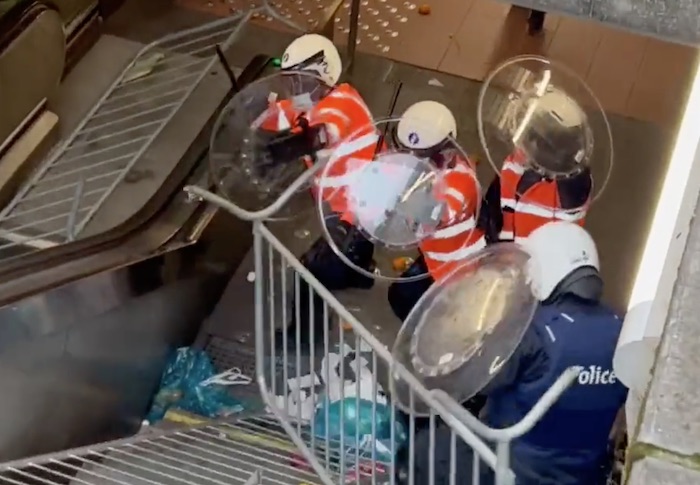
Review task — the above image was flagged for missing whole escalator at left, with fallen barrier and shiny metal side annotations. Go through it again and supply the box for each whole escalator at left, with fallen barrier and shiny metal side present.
[0,9,282,460]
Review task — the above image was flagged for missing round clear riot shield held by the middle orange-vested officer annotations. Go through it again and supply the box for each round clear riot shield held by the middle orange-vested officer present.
[315,119,480,281]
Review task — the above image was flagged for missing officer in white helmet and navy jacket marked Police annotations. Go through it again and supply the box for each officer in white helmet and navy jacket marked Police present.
[415,222,627,485]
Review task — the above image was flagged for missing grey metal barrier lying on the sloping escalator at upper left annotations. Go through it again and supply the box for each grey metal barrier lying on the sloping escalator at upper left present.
[0,14,248,260]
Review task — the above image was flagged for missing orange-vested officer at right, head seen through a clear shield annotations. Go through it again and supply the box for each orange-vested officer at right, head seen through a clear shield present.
[481,88,593,242]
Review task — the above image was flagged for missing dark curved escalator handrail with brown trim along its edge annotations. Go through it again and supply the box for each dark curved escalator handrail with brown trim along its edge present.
[0,50,276,305]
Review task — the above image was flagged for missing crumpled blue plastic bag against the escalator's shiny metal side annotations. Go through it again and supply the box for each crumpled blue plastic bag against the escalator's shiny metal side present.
[146,347,244,423]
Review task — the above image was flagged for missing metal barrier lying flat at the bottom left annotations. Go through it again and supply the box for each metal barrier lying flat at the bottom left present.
[0,418,328,485]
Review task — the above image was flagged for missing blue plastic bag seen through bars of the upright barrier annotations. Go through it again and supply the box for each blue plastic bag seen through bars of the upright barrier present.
[314,397,408,463]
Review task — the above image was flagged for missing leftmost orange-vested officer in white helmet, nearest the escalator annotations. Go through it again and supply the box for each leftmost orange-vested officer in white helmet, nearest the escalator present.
[276,34,377,347]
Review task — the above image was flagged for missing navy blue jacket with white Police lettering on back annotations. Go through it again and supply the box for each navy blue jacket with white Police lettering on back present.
[482,296,627,485]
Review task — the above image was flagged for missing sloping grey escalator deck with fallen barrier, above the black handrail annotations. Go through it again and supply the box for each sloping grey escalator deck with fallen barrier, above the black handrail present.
[0,12,242,292]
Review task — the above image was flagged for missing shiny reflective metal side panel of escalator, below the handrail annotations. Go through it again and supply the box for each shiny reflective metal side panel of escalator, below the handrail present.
[0,260,224,461]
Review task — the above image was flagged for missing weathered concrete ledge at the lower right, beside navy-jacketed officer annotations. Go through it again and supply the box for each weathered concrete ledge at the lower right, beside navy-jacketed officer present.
[628,182,700,485]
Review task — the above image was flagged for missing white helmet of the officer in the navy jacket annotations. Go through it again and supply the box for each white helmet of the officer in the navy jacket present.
[520,221,603,301]
